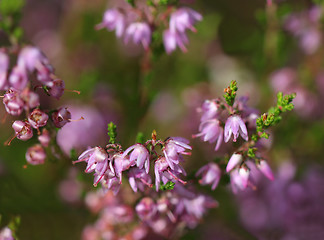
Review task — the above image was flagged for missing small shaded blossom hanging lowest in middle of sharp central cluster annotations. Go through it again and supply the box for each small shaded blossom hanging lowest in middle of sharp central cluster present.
[128,167,152,192]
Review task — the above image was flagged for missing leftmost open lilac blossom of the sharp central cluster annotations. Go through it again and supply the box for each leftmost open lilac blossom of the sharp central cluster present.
[73,147,109,186]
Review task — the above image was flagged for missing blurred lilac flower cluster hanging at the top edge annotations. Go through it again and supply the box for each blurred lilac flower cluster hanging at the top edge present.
[97,0,202,54]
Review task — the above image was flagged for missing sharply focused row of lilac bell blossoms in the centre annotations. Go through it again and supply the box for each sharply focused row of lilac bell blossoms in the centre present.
[74,129,191,194]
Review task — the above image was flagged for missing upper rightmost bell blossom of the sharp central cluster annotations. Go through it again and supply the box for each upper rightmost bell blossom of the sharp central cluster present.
[163,137,192,170]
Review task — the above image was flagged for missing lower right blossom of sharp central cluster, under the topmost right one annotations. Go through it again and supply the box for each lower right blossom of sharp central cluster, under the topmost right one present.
[154,157,186,191]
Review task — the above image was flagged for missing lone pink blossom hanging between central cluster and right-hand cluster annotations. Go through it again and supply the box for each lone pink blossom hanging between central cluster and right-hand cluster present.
[196,163,222,190]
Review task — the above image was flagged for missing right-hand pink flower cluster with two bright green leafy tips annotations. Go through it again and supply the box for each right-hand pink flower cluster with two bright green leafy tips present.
[193,81,294,193]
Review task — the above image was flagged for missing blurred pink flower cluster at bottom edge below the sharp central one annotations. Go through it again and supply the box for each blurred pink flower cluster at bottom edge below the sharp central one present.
[83,183,218,240]
